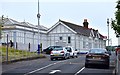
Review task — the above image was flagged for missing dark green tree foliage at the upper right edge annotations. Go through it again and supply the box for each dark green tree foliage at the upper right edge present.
[111,0,120,37]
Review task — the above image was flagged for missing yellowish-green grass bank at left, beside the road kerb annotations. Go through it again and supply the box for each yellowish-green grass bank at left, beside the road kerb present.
[0,46,44,62]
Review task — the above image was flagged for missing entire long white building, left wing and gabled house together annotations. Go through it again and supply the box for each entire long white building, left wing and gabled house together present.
[1,18,106,51]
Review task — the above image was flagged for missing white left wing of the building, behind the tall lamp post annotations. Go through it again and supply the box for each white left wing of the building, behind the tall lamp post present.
[1,18,48,51]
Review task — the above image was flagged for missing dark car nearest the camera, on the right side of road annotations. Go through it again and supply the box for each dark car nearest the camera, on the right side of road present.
[85,48,110,68]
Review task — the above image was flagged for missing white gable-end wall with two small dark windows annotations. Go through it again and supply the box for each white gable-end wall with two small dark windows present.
[48,24,75,47]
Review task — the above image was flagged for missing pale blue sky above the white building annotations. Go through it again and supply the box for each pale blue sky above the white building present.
[0,0,118,45]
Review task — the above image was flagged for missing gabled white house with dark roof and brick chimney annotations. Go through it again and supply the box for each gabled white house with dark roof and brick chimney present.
[47,19,106,50]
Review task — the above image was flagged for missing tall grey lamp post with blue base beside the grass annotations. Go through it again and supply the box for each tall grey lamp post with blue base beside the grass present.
[37,0,41,54]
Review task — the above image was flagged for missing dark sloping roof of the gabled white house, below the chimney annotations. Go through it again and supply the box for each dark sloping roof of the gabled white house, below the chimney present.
[60,20,91,36]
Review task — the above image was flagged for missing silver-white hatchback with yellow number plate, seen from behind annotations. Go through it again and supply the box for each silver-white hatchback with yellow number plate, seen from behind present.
[50,46,70,60]
